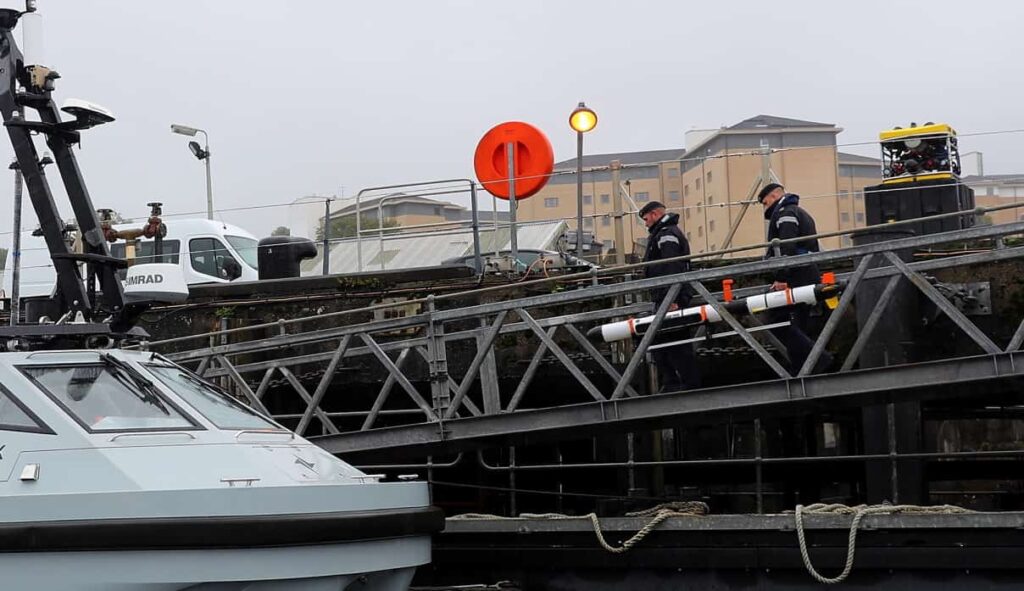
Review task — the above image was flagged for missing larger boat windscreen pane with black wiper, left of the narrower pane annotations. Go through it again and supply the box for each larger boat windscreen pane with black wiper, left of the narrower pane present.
[20,357,198,432]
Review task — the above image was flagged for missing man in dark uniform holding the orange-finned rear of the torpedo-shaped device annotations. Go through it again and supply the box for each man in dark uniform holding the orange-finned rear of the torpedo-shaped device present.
[758,182,833,375]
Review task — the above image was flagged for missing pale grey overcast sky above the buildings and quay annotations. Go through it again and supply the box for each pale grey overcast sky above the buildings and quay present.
[0,0,1024,244]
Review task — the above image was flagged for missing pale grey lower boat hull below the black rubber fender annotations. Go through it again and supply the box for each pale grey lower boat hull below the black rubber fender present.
[0,536,430,591]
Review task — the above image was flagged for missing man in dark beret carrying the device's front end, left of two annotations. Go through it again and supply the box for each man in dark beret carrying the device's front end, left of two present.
[640,201,700,392]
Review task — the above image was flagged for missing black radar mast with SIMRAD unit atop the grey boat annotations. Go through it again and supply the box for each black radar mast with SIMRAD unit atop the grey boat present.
[0,0,187,350]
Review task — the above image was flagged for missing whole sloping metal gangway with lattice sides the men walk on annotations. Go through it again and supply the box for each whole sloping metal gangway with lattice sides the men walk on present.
[147,205,1024,457]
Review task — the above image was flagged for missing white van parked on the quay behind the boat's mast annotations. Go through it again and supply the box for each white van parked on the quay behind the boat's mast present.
[3,219,259,298]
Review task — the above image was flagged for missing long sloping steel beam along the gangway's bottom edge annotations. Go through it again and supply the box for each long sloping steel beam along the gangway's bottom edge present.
[311,352,1024,455]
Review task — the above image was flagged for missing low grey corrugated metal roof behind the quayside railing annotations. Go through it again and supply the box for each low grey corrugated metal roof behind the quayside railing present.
[302,221,566,276]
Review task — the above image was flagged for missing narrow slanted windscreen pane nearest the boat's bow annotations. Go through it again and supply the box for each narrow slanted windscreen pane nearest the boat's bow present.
[146,365,281,429]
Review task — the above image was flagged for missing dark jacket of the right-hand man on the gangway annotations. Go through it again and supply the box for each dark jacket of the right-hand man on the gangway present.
[765,193,821,288]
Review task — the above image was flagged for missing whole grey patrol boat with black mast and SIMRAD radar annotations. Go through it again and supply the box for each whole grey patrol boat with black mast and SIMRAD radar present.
[0,5,443,591]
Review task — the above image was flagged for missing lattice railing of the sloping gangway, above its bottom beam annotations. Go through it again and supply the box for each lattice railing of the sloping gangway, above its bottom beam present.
[151,208,1024,446]
